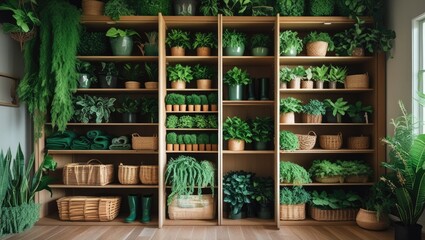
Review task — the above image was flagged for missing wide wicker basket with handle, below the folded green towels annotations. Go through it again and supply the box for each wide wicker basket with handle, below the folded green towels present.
[63,159,114,186]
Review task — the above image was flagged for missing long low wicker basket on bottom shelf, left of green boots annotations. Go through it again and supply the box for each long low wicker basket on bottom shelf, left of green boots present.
[56,196,121,222]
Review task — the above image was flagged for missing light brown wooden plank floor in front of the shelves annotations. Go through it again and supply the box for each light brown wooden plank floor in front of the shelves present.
[1,225,400,240]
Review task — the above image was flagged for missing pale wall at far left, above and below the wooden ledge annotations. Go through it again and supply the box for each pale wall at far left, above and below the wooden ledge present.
[0,31,33,157]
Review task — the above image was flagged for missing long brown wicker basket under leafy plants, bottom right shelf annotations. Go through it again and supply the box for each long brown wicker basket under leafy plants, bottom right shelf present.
[310,206,358,221]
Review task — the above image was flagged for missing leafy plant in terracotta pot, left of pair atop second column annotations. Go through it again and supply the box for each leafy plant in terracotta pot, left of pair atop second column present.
[165,29,190,56]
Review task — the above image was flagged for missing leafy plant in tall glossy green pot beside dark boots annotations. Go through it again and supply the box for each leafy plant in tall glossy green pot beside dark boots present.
[223,67,250,100]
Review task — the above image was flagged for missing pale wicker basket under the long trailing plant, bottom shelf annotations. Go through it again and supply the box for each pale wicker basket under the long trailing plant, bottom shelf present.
[168,194,216,219]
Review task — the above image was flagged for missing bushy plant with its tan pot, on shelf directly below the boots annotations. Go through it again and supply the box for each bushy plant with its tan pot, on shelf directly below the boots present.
[223,117,252,151]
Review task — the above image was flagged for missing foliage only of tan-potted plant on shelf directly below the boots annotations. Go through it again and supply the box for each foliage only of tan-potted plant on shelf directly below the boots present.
[223,117,252,143]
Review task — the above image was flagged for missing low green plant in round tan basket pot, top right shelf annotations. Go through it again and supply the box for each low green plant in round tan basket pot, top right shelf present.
[304,31,335,57]
